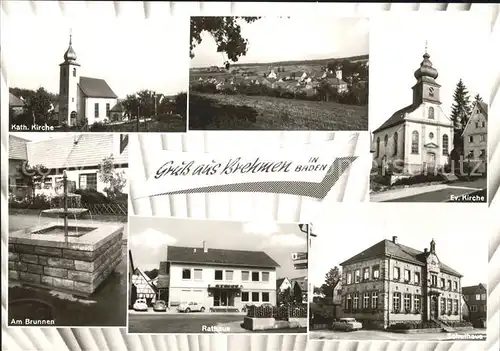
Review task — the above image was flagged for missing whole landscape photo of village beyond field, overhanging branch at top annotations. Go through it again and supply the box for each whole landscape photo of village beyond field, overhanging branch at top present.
[189,17,369,130]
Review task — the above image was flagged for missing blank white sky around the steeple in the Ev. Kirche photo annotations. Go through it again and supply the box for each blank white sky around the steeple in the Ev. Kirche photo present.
[369,11,491,130]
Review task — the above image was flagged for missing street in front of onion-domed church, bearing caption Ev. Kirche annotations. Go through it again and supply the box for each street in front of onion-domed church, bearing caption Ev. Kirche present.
[370,178,486,202]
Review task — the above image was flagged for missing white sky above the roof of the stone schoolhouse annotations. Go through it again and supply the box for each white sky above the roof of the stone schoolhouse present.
[309,203,489,286]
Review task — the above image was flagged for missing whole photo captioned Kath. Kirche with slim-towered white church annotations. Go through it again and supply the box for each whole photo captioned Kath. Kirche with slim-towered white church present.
[2,16,189,133]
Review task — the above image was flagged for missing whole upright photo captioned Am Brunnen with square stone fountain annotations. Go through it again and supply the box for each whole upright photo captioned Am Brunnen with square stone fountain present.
[7,133,128,327]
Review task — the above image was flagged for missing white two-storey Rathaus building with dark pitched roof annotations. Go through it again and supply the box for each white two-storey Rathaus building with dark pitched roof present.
[167,244,279,311]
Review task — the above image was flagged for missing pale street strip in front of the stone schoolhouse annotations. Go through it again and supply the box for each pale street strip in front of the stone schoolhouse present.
[309,329,486,341]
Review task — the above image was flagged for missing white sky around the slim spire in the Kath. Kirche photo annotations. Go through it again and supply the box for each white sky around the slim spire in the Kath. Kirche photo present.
[2,11,189,98]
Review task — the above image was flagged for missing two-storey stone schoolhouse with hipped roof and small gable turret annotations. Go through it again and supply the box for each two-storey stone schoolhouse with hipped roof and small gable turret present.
[340,236,462,329]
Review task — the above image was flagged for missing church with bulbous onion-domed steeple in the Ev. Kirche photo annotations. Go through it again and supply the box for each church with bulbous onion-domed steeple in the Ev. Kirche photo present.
[372,50,453,174]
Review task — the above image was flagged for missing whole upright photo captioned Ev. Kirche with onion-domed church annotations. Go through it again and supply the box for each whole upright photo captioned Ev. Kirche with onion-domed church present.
[370,13,489,203]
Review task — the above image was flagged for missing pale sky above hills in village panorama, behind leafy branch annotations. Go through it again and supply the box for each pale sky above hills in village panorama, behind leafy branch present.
[191,16,369,67]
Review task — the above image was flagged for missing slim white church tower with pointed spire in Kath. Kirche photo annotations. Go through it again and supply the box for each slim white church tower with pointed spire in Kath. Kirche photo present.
[59,32,80,126]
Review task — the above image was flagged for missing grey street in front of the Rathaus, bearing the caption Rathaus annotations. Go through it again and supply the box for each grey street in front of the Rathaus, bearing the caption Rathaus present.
[128,312,307,333]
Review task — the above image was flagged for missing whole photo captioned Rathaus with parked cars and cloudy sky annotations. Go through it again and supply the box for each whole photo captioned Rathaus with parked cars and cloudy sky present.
[128,217,308,334]
